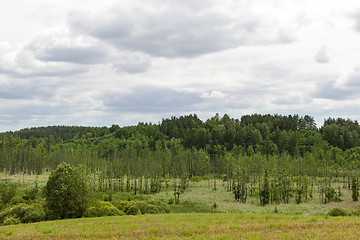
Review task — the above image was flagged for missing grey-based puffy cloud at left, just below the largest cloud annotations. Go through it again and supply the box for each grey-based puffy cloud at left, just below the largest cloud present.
[20,34,151,73]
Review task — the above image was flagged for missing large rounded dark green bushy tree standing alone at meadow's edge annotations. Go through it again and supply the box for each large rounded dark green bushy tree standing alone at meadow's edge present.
[43,163,89,219]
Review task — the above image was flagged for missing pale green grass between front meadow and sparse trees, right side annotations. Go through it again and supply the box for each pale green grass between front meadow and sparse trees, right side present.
[154,178,359,215]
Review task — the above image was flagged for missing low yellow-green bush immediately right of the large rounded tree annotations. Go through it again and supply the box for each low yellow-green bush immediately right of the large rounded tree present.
[84,201,125,217]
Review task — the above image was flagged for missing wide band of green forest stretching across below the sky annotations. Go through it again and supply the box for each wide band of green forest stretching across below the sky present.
[0,114,360,224]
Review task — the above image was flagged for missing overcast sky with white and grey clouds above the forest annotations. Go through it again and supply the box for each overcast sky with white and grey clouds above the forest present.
[0,0,360,132]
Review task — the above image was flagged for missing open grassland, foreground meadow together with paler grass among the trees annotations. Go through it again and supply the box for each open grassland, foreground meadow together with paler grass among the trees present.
[0,174,360,239]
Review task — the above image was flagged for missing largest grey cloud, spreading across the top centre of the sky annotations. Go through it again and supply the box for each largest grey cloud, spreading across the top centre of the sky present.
[69,1,292,58]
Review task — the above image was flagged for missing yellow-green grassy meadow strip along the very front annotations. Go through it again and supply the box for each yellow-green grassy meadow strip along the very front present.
[0,213,360,239]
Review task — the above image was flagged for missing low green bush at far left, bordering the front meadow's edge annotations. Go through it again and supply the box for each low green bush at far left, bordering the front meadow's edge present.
[0,203,45,223]
